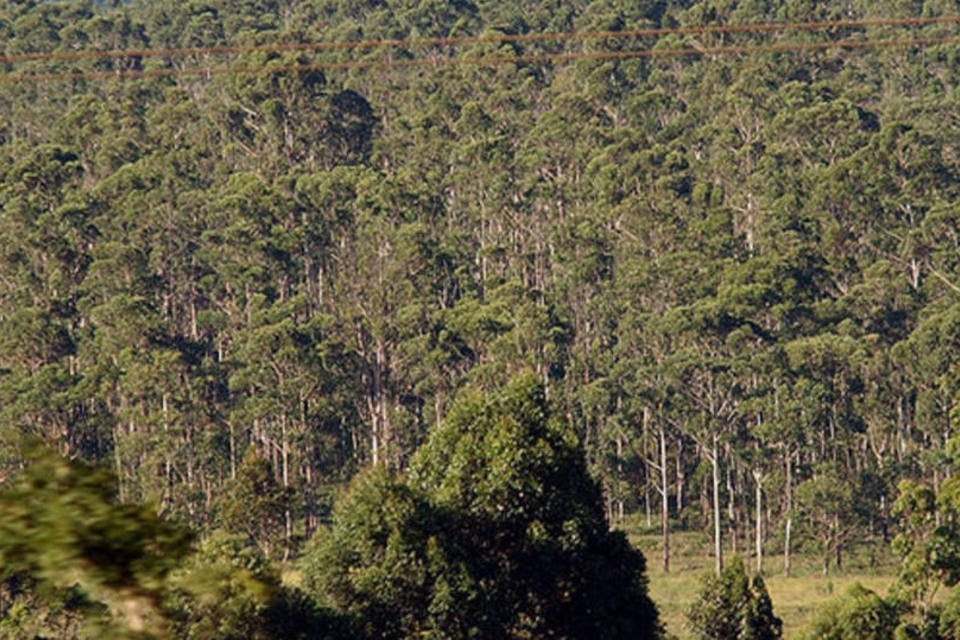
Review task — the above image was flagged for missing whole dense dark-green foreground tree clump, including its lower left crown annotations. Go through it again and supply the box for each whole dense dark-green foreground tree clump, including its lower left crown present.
[304,376,661,638]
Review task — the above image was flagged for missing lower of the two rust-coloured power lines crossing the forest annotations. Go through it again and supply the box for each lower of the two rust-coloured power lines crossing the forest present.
[0,36,960,84]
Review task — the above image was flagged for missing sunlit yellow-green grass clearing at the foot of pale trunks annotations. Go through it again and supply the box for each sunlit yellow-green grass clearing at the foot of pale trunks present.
[626,527,895,640]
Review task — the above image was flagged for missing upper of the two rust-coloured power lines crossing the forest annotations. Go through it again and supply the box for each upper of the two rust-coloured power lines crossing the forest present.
[0,16,960,64]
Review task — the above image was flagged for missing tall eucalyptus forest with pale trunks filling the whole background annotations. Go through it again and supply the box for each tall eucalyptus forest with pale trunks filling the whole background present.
[0,0,960,636]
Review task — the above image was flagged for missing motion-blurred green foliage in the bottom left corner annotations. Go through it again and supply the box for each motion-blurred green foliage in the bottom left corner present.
[0,448,190,637]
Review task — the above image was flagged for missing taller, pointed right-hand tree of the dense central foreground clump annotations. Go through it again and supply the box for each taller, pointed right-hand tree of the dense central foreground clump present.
[410,375,657,638]
